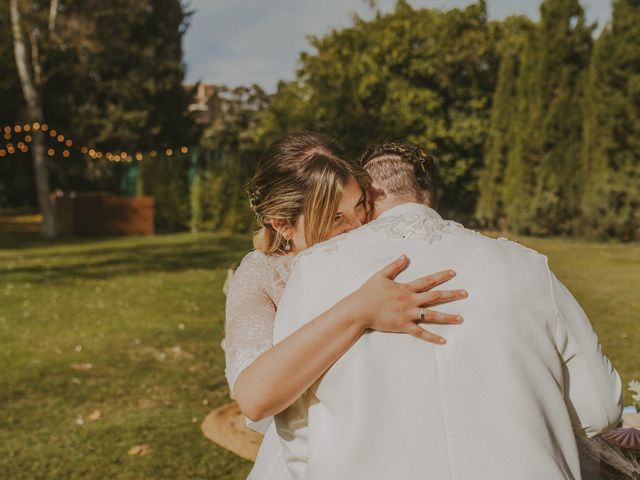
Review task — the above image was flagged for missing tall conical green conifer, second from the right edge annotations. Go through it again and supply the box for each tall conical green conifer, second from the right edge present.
[504,0,594,234]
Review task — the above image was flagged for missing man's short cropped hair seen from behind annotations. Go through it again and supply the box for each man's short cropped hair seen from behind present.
[360,143,438,208]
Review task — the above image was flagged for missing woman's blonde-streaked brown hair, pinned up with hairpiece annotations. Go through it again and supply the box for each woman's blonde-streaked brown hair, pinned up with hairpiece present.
[248,132,371,255]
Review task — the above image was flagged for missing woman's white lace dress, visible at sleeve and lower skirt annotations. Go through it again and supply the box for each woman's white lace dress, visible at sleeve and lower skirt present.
[225,250,293,480]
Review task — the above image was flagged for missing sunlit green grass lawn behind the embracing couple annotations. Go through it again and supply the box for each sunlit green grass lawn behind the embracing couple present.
[0,222,640,480]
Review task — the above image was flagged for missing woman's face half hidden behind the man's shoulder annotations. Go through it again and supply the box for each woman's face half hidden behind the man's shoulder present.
[292,177,367,250]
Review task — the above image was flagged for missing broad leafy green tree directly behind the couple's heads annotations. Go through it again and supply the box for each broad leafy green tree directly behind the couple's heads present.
[263,0,497,216]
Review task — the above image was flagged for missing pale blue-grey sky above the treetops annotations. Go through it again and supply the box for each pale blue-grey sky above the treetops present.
[183,0,611,93]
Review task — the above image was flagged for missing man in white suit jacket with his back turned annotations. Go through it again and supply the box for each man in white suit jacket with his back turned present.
[274,144,622,480]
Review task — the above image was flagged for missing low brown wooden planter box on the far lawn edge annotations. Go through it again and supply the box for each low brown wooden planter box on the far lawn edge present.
[51,192,153,237]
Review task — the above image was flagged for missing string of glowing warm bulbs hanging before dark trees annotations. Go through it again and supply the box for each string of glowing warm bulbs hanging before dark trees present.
[0,122,189,163]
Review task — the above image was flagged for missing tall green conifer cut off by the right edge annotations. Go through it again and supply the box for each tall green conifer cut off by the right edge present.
[582,0,640,240]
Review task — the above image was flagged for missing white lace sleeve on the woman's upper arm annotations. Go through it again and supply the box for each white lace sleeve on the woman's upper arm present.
[225,251,276,398]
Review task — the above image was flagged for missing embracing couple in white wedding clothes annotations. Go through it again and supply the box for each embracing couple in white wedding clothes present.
[225,132,622,480]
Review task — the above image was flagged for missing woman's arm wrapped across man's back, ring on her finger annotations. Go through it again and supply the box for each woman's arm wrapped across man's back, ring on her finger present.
[225,253,466,421]
